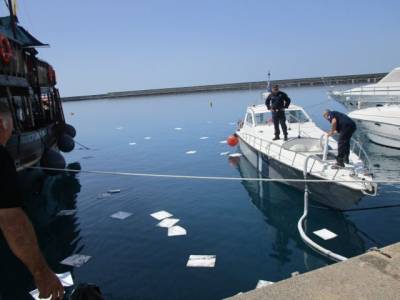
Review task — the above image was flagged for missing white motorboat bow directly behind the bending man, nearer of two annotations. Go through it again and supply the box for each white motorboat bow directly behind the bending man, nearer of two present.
[349,105,400,149]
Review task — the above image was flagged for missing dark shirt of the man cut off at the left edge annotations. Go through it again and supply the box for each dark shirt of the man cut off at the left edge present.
[0,145,22,209]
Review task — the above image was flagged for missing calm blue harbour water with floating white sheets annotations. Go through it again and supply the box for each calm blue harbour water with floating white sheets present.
[0,88,400,299]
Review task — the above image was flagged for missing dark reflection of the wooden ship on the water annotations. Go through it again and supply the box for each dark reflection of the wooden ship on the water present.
[0,166,81,300]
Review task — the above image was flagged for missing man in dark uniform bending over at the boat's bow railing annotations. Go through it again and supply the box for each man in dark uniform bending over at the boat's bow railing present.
[324,110,357,169]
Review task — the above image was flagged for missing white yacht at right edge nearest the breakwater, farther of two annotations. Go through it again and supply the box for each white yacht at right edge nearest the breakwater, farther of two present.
[329,67,400,111]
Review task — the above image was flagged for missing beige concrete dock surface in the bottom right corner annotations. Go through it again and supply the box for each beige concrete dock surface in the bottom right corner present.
[229,243,400,300]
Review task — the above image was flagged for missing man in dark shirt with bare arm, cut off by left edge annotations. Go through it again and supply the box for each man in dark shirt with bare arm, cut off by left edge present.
[0,102,64,300]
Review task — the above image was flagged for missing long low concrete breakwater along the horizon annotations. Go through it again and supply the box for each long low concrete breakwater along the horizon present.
[62,73,387,102]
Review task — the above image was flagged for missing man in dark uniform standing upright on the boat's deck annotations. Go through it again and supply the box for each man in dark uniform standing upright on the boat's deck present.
[265,84,290,141]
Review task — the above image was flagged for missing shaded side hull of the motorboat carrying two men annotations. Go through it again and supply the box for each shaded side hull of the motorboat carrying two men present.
[239,139,364,210]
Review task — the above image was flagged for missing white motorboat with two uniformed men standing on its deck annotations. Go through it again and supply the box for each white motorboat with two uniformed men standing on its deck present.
[236,104,377,210]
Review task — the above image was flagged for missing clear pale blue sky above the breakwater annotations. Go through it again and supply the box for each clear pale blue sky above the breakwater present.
[8,0,400,96]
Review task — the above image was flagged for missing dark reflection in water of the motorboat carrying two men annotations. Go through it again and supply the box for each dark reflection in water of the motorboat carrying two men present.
[234,158,374,270]
